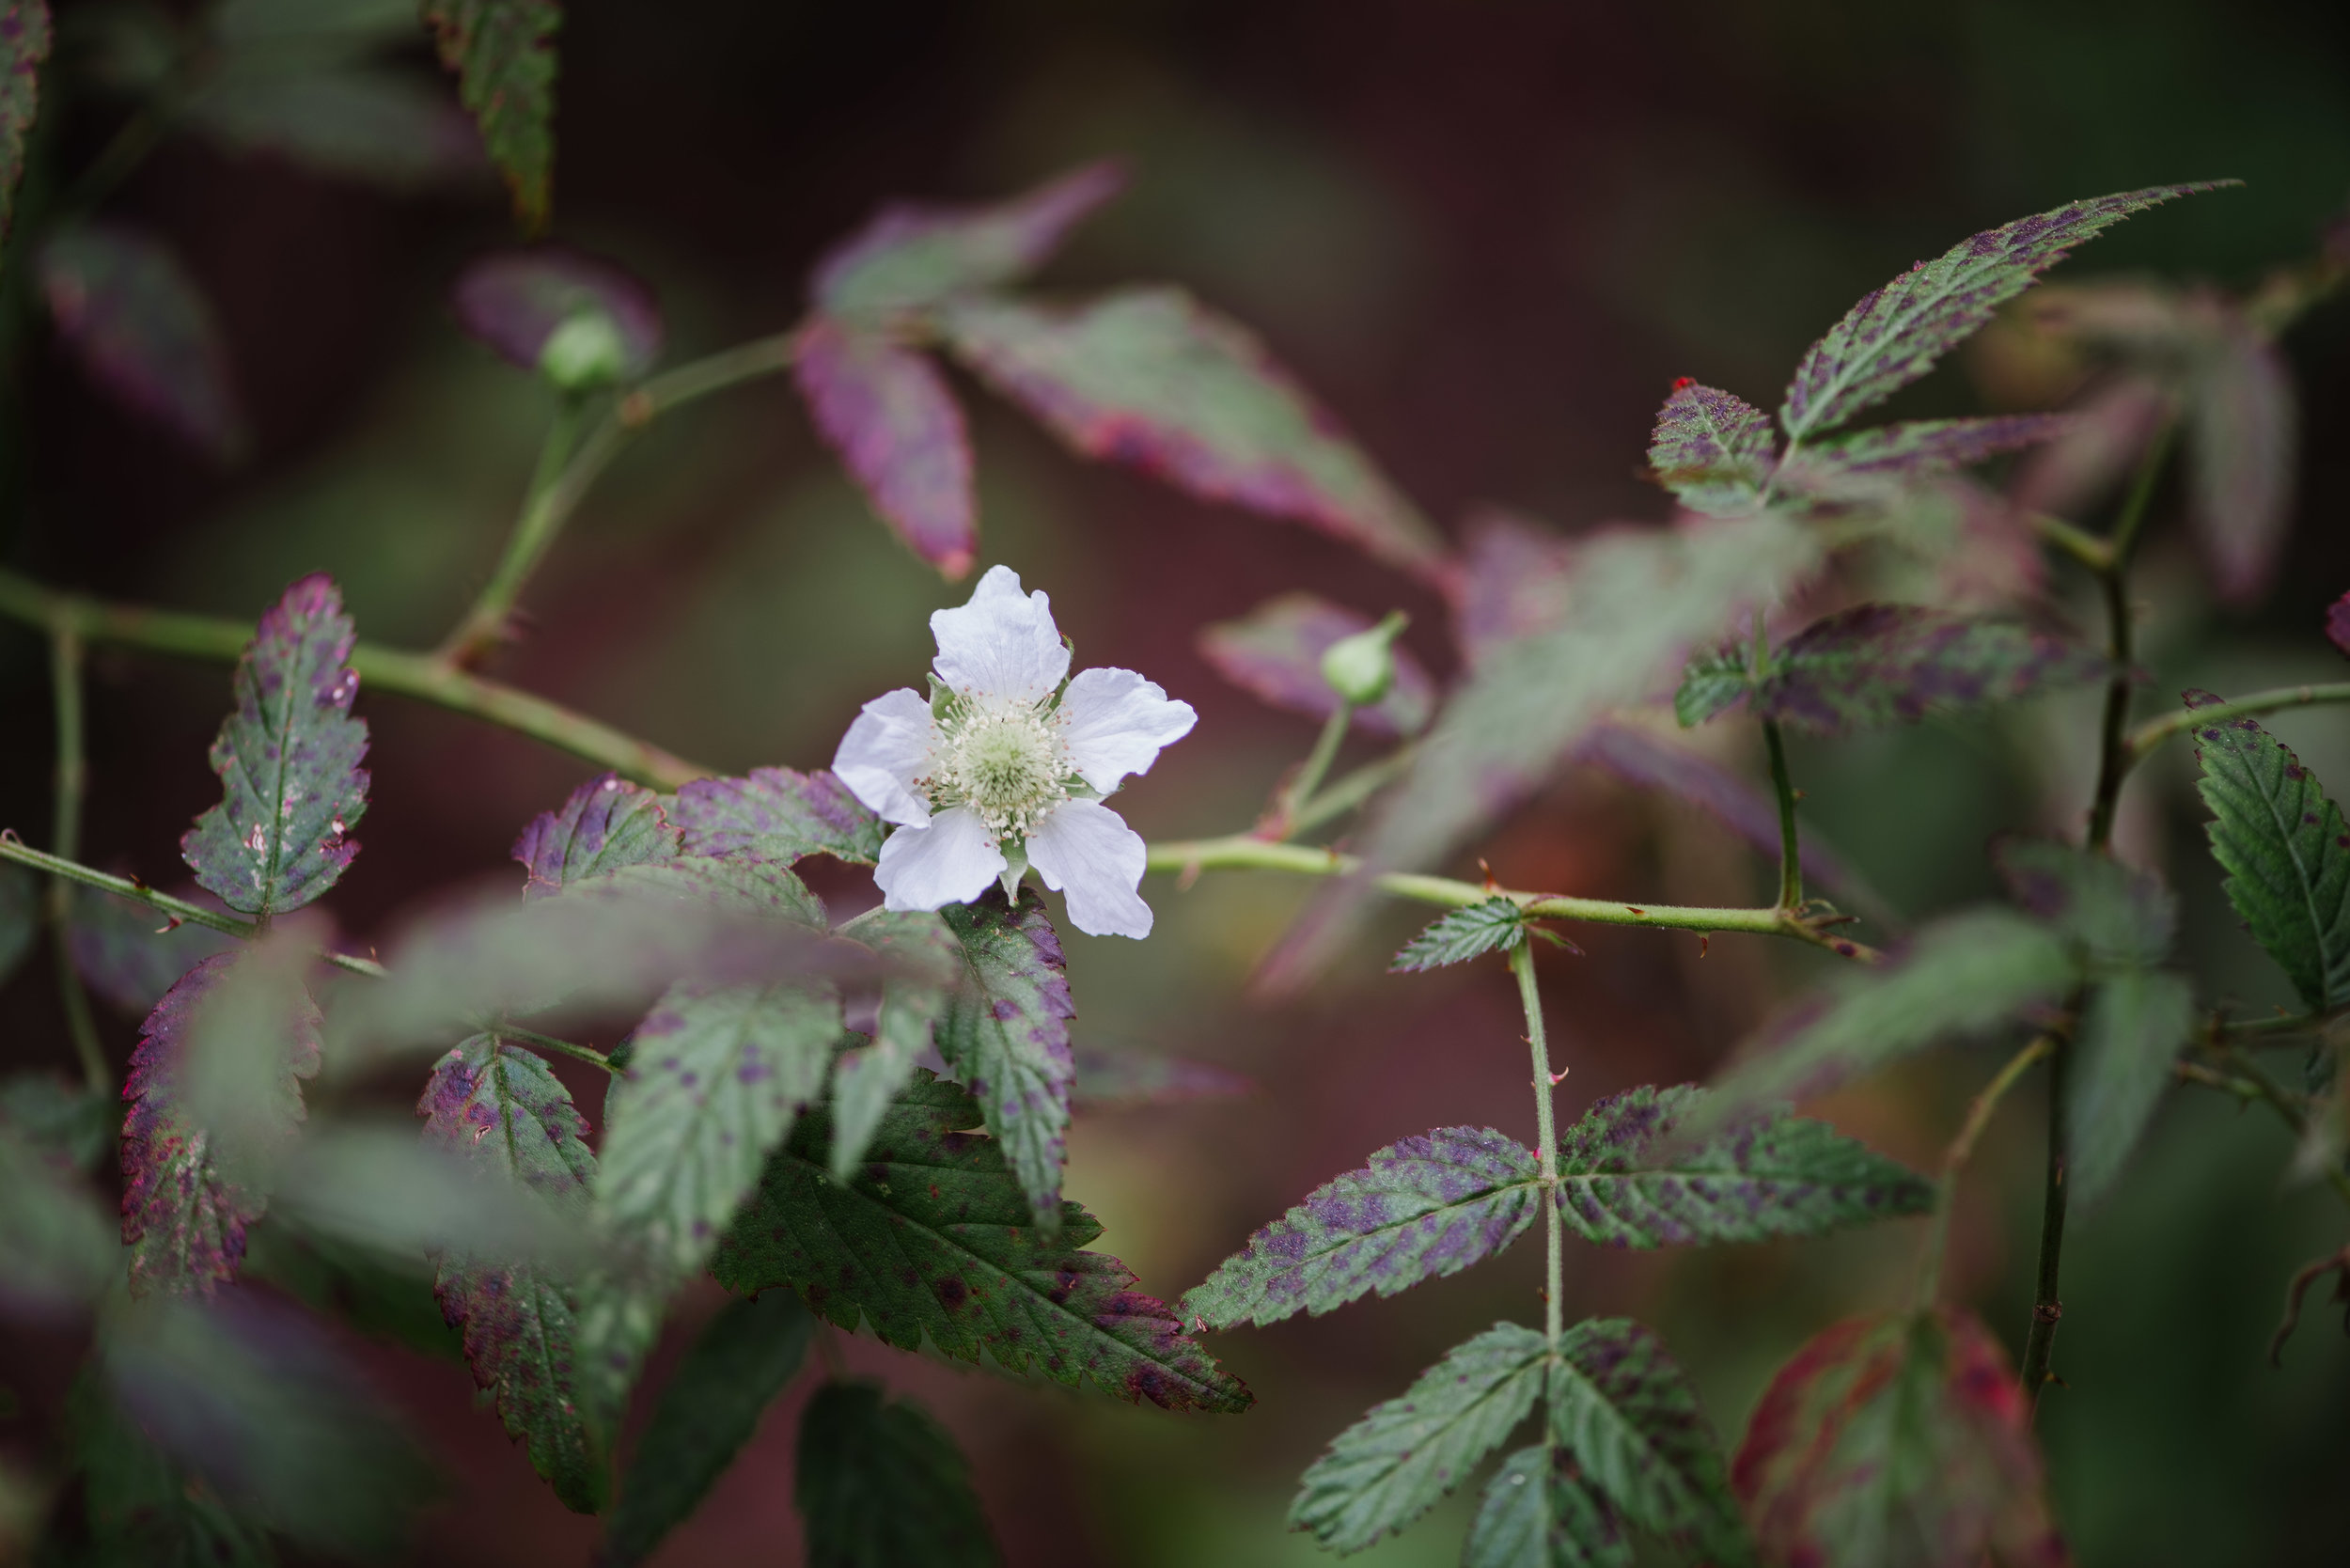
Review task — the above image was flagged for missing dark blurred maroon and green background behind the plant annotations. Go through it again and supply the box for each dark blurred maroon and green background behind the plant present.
[0,0,2350,1568]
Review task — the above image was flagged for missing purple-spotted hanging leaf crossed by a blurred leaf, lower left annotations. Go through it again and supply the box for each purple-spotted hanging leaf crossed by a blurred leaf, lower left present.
[416,1034,611,1513]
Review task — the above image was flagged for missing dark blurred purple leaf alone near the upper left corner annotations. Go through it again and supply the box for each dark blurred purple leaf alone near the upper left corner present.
[36,226,247,463]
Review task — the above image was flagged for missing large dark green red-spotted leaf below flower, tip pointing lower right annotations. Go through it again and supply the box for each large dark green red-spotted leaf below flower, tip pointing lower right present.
[713,1070,1250,1413]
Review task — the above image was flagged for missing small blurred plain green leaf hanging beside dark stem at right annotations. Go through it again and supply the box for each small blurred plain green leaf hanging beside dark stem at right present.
[2063,968,2195,1203]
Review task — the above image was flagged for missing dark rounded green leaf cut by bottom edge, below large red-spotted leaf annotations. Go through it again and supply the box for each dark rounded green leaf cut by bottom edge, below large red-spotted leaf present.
[792,1382,1001,1568]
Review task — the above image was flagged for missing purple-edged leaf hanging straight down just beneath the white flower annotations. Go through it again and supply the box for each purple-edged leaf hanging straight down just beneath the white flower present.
[938,888,1076,1231]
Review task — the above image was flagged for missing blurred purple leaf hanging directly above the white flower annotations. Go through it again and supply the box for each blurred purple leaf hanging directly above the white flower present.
[792,315,980,581]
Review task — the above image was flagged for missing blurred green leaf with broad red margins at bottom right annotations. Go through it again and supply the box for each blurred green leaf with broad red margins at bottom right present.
[1730,1307,2068,1568]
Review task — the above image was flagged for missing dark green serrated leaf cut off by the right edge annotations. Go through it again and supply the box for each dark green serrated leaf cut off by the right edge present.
[2188,691,2350,1013]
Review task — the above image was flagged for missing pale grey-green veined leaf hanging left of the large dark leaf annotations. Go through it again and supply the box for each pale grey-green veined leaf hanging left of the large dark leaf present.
[595,980,844,1277]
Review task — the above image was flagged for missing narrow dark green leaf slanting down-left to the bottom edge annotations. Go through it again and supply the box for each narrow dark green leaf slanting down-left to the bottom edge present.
[597,1291,816,1568]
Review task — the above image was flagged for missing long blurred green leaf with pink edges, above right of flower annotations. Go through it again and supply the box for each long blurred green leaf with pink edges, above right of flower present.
[940,287,1446,576]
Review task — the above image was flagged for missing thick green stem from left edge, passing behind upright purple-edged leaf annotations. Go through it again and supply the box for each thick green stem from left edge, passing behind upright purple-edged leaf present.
[0,572,714,790]
